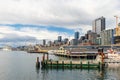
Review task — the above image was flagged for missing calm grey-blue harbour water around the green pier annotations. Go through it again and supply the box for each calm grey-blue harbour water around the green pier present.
[0,51,120,80]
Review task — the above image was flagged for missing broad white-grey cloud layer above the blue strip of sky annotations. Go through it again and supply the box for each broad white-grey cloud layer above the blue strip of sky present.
[0,0,120,28]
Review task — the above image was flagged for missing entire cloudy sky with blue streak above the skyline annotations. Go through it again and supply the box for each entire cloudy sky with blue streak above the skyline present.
[0,0,120,46]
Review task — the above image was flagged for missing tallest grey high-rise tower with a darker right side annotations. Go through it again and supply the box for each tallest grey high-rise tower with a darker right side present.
[92,16,105,34]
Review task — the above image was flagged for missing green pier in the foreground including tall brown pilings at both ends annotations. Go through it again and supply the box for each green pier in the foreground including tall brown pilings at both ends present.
[41,50,105,69]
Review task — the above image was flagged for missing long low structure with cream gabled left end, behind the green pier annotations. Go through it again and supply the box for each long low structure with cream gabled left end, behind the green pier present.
[54,47,106,59]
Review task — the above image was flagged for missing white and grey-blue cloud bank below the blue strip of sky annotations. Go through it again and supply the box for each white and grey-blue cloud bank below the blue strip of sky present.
[0,26,70,42]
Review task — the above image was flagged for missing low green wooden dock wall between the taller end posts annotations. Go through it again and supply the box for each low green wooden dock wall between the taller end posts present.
[41,61,102,69]
